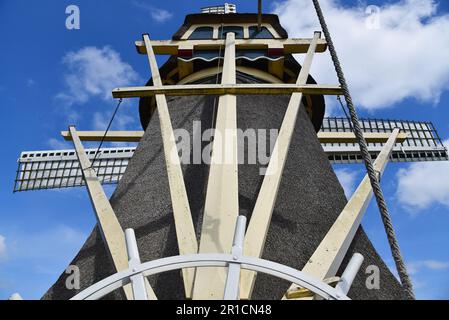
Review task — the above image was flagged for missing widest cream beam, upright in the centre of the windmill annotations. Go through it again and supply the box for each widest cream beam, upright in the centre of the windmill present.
[193,33,239,299]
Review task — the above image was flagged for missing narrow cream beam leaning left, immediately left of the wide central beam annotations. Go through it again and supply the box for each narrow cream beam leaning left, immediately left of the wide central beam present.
[143,34,198,299]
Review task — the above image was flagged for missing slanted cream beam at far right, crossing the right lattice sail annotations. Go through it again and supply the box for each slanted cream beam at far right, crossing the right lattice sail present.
[284,129,399,299]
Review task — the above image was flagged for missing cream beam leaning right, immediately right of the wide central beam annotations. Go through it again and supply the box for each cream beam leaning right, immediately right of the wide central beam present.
[241,32,321,299]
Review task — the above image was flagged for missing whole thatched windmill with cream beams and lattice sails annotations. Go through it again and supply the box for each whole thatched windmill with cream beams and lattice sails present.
[14,1,448,299]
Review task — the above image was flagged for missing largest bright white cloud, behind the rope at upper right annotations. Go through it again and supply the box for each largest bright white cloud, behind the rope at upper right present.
[274,0,449,109]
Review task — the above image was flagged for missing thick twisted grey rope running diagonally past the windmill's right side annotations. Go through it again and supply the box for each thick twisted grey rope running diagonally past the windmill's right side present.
[312,0,415,299]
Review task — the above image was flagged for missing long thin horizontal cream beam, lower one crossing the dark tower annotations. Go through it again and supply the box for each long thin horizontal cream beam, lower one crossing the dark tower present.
[112,83,343,98]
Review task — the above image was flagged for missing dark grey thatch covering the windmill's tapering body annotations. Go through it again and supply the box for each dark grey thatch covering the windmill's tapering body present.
[43,76,405,299]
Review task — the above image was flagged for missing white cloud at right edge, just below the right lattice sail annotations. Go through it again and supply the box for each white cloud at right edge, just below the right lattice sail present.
[396,141,449,213]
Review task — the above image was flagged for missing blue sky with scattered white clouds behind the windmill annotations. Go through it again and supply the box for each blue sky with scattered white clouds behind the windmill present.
[0,0,449,299]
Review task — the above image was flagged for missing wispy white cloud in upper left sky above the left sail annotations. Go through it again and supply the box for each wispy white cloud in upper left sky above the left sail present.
[57,46,140,106]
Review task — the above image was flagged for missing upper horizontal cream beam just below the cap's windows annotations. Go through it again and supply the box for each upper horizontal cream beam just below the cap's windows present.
[135,39,327,55]
